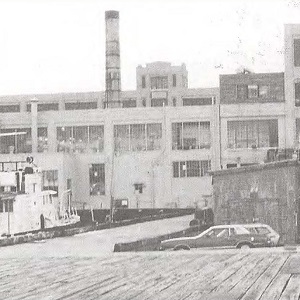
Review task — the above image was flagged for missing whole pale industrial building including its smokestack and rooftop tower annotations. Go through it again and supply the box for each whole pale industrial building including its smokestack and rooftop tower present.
[0,11,300,208]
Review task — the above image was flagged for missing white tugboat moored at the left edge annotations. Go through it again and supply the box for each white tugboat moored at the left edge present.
[0,157,80,237]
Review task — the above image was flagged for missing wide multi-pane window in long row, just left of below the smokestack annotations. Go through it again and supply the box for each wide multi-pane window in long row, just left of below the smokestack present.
[56,126,104,153]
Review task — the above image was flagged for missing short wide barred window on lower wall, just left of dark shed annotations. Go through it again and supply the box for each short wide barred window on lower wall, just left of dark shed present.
[173,160,211,178]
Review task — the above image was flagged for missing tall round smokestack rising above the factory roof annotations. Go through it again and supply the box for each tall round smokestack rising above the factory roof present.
[105,10,121,108]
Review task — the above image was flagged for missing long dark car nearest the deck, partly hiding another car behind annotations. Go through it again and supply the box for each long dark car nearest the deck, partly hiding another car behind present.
[160,225,271,250]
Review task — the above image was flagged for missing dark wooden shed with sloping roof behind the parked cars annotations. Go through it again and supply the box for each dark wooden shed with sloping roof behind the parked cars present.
[212,160,300,243]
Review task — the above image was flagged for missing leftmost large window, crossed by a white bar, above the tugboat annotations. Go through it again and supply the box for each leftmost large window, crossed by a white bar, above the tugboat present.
[0,128,32,154]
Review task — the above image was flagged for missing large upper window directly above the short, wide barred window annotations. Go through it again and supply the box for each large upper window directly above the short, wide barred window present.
[172,122,211,150]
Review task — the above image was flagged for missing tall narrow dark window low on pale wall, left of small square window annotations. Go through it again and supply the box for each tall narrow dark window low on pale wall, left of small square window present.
[89,164,105,196]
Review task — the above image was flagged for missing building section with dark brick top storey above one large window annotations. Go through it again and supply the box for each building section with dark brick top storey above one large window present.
[220,72,288,169]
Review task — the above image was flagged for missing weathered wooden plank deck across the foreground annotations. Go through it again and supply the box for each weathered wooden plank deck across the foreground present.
[0,249,300,300]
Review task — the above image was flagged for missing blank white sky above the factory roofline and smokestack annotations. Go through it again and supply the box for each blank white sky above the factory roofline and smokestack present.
[0,0,300,95]
